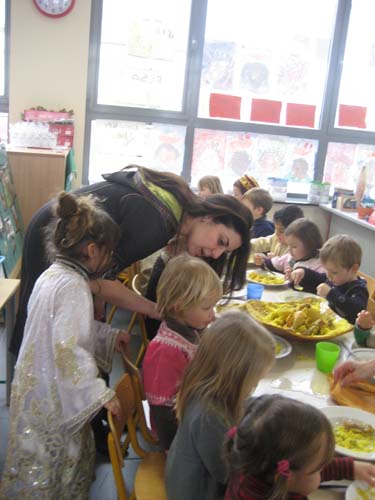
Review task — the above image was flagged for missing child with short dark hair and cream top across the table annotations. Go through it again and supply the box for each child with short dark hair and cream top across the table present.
[249,205,303,262]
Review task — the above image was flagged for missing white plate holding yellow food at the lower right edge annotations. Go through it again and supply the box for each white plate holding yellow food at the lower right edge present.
[322,406,375,460]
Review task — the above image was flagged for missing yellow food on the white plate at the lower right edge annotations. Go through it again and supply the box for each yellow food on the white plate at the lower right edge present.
[333,419,375,453]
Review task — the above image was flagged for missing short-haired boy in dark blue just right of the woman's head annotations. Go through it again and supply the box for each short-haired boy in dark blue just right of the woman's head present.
[241,187,275,238]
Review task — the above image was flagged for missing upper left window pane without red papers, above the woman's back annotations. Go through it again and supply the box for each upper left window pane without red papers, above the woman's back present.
[98,0,191,111]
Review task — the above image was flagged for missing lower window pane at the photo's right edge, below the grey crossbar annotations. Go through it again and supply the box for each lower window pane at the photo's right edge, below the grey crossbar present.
[324,142,375,198]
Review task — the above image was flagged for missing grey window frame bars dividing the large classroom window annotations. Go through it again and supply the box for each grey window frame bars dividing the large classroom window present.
[82,0,375,187]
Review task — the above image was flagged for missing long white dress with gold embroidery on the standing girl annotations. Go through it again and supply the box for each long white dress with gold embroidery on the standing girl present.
[0,262,119,500]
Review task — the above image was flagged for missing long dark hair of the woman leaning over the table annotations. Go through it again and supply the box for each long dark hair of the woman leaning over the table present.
[137,166,253,291]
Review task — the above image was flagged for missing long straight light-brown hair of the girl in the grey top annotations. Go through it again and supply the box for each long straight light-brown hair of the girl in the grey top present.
[176,311,275,425]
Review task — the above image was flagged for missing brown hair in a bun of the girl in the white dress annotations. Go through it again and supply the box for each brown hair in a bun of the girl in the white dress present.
[46,191,120,260]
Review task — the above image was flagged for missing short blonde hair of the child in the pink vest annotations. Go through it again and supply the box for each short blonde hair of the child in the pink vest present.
[156,254,223,320]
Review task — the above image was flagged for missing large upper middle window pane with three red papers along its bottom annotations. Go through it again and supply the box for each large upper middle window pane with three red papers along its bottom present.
[199,0,337,128]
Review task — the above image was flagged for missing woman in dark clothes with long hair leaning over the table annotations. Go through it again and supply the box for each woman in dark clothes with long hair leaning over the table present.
[10,166,253,354]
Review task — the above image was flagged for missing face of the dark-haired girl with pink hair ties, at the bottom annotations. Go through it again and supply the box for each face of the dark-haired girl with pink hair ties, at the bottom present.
[288,434,327,496]
